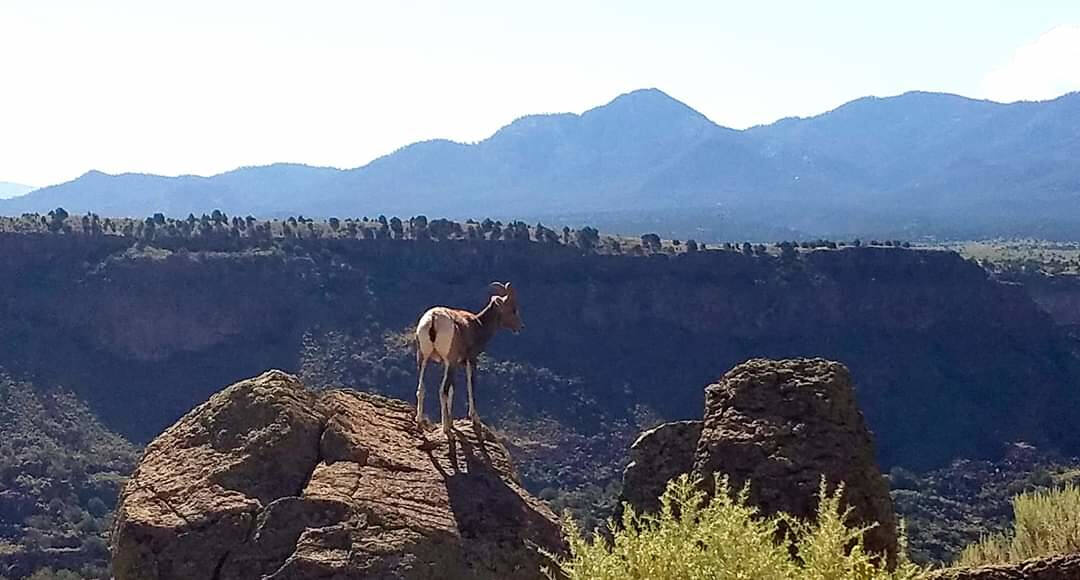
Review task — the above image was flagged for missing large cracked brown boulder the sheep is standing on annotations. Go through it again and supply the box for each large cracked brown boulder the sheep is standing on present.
[112,370,563,580]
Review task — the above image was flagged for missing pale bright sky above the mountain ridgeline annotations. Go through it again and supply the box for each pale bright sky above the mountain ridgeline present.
[0,0,1080,186]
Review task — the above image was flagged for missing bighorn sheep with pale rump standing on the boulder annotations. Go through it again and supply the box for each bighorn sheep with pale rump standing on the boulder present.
[416,282,525,439]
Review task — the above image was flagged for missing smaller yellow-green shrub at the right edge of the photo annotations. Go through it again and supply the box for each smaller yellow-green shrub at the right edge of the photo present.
[957,483,1080,566]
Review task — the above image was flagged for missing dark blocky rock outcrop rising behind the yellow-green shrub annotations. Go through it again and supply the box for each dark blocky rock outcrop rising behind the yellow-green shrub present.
[623,359,897,561]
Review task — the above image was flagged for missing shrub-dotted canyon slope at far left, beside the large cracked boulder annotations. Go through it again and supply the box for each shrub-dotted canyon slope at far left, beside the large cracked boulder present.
[0,374,138,580]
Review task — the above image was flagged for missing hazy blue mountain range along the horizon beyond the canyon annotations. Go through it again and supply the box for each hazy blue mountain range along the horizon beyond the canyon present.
[0,89,1080,241]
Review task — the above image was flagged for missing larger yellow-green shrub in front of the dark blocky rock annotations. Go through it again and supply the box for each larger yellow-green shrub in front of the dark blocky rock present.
[545,475,924,580]
